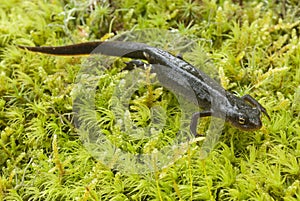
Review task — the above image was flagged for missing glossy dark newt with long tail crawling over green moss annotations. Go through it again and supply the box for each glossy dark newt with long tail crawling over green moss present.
[20,41,270,135]
